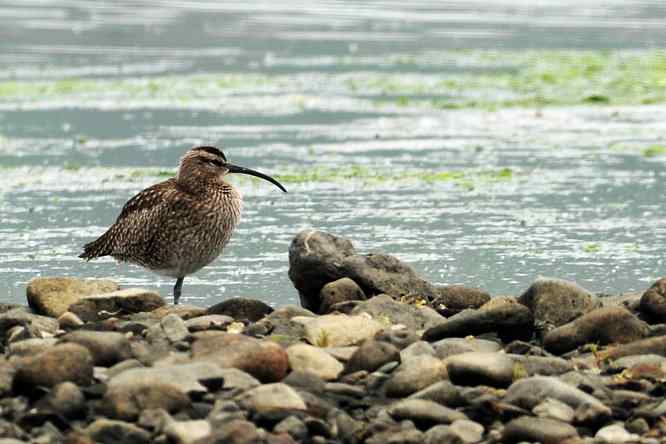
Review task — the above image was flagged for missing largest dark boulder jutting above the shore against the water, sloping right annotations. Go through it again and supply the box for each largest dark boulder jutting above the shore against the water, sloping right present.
[289,230,437,312]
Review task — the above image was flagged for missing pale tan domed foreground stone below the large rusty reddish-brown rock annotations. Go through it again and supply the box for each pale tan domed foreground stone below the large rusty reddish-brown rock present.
[237,383,306,413]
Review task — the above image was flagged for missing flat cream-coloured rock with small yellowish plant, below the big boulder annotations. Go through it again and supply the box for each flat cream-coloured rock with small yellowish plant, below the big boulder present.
[293,314,384,347]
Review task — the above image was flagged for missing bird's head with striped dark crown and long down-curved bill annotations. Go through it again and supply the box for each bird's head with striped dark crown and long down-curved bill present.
[176,146,287,193]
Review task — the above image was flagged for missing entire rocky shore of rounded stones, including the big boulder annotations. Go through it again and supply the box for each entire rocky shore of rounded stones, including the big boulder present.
[0,231,666,444]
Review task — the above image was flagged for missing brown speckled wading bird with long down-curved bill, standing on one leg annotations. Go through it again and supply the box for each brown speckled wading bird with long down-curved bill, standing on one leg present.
[79,146,287,305]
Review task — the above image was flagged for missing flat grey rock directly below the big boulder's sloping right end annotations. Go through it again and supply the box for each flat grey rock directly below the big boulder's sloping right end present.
[351,294,446,331]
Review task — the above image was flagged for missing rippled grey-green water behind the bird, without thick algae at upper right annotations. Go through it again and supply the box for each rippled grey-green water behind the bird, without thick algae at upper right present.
[0,0,666,305]
